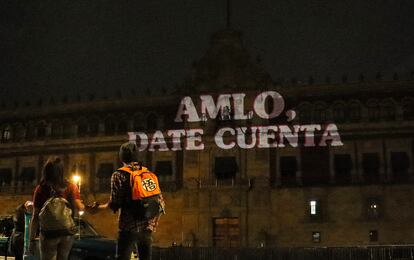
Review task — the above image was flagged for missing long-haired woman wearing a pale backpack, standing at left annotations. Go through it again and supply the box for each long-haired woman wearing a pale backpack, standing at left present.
[29,157,85,260]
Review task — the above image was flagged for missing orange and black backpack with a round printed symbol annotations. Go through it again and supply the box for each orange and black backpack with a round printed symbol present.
[118,164,165,220]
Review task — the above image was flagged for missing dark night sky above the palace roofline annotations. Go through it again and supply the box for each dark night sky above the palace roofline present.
[0,0,414,103]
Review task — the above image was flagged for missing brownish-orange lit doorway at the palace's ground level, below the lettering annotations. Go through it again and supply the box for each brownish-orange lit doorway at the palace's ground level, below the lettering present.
[213,218,240,247]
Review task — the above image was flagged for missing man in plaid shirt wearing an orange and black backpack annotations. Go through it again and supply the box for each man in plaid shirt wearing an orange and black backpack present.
[94,143,165,260]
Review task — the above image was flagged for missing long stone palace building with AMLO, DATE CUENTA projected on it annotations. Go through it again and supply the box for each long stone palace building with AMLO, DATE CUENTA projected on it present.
[0,29,414,247]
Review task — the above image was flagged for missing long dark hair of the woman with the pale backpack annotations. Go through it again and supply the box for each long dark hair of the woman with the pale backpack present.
[40,157,66,188]
